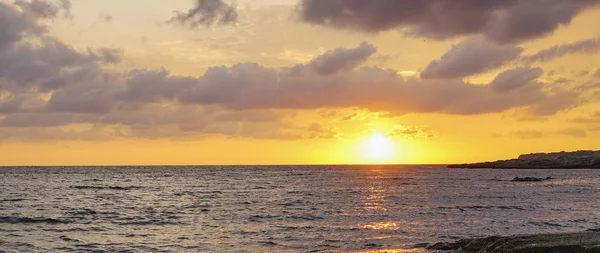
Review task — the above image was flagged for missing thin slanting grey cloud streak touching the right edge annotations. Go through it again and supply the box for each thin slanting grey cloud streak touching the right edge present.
[521,38,600,64]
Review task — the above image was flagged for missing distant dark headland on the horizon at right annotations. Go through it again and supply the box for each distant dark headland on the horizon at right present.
[448,150,600,169]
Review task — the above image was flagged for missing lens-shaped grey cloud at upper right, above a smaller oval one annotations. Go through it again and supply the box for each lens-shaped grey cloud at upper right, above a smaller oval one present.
[421,37,523,79]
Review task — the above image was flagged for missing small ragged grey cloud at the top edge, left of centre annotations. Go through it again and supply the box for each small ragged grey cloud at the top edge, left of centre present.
[167,0,238,28]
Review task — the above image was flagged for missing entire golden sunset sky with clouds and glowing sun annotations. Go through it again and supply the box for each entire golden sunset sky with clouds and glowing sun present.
[0,0,600,166]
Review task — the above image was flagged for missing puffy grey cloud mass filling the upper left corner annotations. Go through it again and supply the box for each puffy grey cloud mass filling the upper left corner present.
[0,0,122,95]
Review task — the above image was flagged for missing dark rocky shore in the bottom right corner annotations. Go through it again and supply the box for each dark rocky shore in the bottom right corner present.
[425,230,600,253]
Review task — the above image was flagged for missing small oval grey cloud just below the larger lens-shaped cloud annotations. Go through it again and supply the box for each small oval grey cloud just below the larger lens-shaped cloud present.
[490,67,544,93]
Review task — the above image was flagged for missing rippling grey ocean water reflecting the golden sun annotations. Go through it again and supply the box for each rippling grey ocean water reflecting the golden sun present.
[0,166,600,252]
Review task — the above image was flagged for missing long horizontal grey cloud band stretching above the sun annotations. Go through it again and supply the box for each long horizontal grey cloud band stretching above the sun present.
[70,63,577,114]
